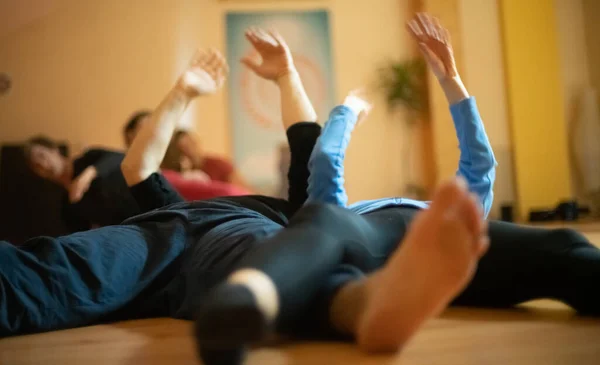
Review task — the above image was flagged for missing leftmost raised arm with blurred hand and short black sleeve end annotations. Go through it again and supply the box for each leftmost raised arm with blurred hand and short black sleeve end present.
[121,50,227,210]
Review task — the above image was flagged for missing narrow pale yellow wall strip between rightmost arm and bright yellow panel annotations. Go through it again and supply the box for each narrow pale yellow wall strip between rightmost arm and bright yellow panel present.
[457,0,516,217]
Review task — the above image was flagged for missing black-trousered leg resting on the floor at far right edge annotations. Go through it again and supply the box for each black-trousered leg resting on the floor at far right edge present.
[455,222,600,315]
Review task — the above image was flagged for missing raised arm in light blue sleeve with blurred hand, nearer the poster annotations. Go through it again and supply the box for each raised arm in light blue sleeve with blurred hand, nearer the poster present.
[308,91,371,207]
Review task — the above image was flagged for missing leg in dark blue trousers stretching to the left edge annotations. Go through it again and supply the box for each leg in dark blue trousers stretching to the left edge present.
[0,219,186,336]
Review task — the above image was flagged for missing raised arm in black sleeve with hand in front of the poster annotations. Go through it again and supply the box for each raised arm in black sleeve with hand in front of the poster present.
[242,29,321,208]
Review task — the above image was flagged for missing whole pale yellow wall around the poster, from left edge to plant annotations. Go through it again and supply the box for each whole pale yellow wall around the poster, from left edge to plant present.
[0,0,408,200]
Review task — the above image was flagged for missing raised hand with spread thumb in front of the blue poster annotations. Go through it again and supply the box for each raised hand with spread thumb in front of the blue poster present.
[241,28,295,81]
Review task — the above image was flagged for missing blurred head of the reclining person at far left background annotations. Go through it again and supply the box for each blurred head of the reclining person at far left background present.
[23,136,69,181]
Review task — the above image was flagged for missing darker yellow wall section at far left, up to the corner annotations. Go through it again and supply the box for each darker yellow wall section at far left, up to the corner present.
[0,0,185,151]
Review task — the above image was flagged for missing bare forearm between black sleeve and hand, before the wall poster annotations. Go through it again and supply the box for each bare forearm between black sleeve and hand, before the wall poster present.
[277,70,317,130]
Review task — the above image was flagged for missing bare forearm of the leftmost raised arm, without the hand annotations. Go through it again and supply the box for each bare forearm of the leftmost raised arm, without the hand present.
[121,87,190,186]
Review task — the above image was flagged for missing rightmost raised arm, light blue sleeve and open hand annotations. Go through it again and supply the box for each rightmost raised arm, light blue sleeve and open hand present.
[407,13,497,217]
